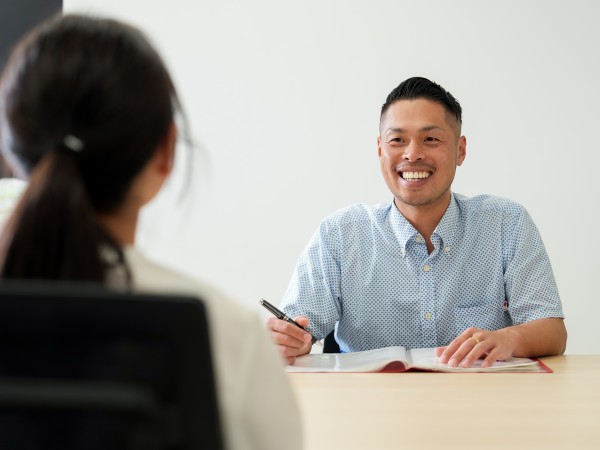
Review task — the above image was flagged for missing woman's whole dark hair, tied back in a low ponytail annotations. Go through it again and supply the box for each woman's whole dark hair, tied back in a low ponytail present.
[0,15,178,282]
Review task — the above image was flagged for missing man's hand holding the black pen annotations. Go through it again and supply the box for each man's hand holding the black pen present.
[267,316,312,364]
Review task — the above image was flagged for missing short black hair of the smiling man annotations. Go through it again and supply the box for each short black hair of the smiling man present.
[379,77,462,126]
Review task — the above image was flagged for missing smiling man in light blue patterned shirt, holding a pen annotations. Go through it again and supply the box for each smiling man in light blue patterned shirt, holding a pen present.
[267,77,567,367]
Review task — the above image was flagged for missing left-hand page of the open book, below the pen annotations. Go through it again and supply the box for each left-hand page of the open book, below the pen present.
[285,347,408,372]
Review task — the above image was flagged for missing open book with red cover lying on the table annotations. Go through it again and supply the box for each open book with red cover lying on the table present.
[285,347,552,372]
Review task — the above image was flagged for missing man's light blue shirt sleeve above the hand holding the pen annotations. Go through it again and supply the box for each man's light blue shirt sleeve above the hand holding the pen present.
[281,219,341,339]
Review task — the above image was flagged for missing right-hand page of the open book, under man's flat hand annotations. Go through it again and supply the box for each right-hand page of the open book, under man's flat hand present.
[407,348,546,372]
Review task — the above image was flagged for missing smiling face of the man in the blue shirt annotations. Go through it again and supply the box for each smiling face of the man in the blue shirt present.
[377,99,466,211]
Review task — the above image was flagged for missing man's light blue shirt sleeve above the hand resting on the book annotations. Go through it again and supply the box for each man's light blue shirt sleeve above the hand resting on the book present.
[504,207,564,325]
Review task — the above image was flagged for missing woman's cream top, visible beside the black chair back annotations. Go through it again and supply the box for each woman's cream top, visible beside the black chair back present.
[125,247,302,450]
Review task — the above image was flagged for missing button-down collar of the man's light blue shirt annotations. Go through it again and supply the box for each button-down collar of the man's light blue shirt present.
[388,193,459,254]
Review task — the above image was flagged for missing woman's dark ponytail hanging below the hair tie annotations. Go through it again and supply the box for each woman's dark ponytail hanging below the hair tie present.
[0,149,122,282]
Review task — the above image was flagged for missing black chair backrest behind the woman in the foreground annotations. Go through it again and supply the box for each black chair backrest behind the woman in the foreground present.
[0,282,223,450]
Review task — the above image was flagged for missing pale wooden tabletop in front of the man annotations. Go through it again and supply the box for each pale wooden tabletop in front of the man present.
[289,355,600,450]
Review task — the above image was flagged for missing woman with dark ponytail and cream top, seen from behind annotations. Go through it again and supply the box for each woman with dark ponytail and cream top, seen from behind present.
[0,15,302,450]
